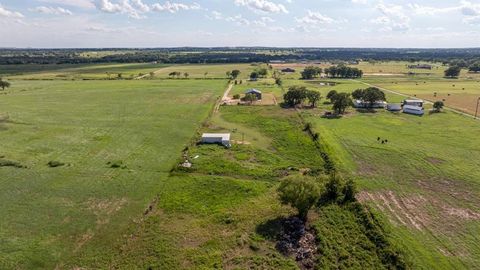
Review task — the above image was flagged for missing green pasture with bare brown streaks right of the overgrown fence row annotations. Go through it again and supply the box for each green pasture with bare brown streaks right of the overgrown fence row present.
[305,106,480,269]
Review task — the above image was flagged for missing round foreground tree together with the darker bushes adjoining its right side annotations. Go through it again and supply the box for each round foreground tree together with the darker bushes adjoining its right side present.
[277,175,357,221]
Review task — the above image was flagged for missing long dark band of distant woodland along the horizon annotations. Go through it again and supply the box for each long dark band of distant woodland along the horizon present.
[0,47,480,65]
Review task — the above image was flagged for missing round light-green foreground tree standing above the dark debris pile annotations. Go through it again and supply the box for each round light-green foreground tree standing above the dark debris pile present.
[278,177,321,221]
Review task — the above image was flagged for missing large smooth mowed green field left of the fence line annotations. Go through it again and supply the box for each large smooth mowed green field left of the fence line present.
[0,67,226,269]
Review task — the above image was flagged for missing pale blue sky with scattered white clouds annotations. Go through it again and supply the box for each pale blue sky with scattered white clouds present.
[0,0,480,48]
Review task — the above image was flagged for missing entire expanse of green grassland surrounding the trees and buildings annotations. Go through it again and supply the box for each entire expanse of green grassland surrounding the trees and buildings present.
[0,62,480,269]
